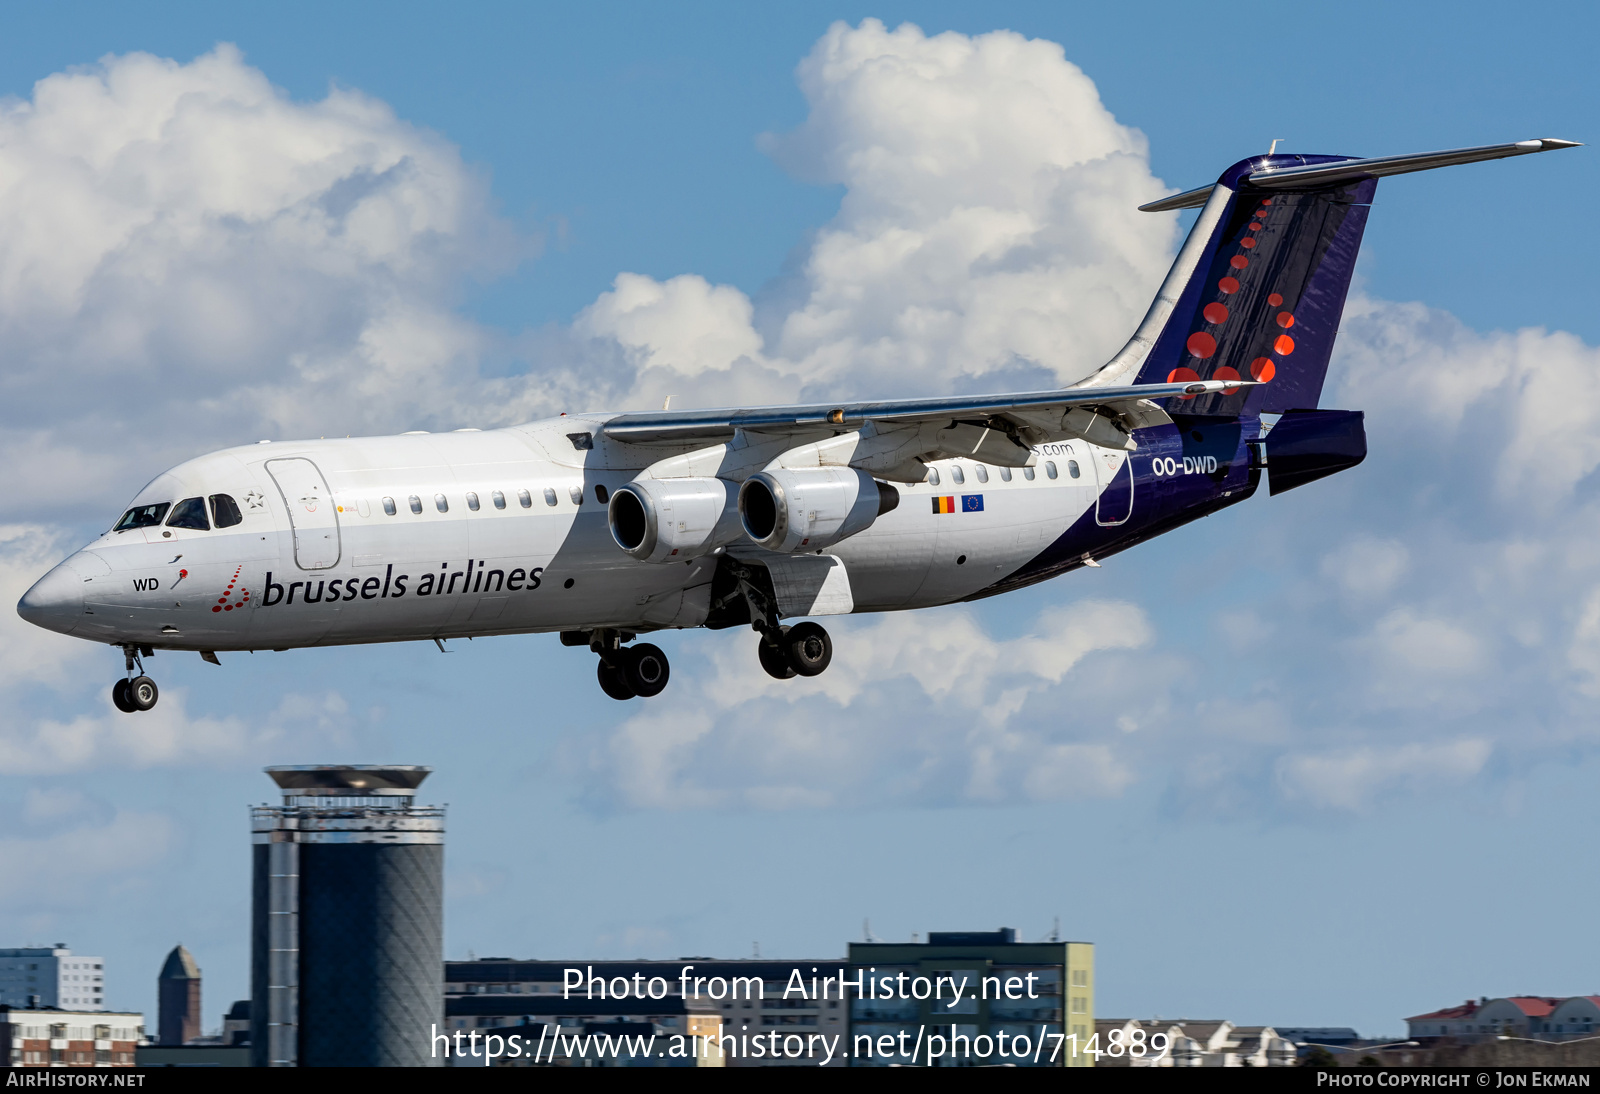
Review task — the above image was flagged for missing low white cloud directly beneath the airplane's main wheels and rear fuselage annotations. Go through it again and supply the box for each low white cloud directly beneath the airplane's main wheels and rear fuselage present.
[568,601,1152,809]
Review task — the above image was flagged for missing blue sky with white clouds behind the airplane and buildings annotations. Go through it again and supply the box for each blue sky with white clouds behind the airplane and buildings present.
[0,3,1600,1033]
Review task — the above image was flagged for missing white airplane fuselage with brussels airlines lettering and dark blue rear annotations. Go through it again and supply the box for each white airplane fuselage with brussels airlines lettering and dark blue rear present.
[15,407,1259,651]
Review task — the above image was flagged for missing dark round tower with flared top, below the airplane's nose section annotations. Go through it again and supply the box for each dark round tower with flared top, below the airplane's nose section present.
[250,765,445,1067]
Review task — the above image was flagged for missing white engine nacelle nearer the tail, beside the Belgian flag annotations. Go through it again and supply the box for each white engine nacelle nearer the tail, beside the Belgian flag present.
[739,467,899,555]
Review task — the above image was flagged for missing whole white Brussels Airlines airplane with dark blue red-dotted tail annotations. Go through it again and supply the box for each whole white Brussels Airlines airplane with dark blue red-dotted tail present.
[18,139,1574,712]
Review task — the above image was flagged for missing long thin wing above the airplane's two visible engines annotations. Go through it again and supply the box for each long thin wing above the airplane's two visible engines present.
[602,379,1253,445]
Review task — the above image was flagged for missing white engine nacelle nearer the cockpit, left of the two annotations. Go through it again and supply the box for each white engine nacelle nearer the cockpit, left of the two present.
[606,478,741,563]
